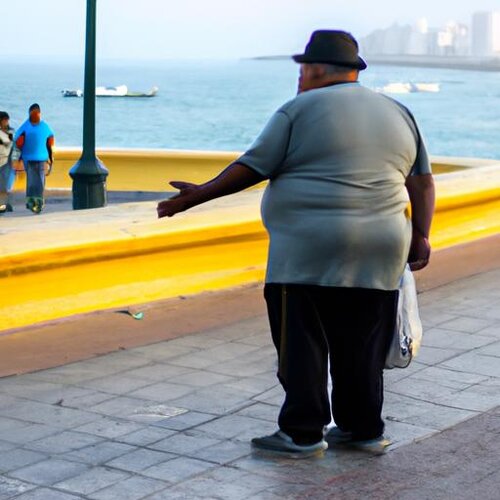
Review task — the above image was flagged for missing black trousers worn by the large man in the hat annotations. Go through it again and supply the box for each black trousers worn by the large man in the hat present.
[264,284,398,444]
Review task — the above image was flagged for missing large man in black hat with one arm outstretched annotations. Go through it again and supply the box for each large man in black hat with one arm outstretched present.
[157,30,434,457]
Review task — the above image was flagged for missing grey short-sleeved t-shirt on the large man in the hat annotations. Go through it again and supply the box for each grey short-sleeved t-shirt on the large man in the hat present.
[237,82,431,290]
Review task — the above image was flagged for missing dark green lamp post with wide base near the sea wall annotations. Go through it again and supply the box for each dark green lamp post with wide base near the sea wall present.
[69,0,108,210]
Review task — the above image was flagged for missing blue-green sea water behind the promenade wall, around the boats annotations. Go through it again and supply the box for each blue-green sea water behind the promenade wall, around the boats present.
[0,59,500,159]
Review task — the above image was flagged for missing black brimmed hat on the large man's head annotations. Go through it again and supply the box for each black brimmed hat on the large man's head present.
[292,30,366,70]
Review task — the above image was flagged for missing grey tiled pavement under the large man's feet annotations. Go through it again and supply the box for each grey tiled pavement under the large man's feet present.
[0,270,500,500]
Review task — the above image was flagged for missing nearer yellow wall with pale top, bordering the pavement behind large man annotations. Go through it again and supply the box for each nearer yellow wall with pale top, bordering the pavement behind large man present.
[0,154,500,333]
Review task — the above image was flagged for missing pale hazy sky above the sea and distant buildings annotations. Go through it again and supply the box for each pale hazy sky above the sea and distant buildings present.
[0,0,500,59]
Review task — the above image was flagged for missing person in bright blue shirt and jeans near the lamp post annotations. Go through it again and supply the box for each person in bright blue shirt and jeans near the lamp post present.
[14,104,54,214]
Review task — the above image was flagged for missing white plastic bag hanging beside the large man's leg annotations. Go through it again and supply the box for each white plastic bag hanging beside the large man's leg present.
[385,264,422,369]
